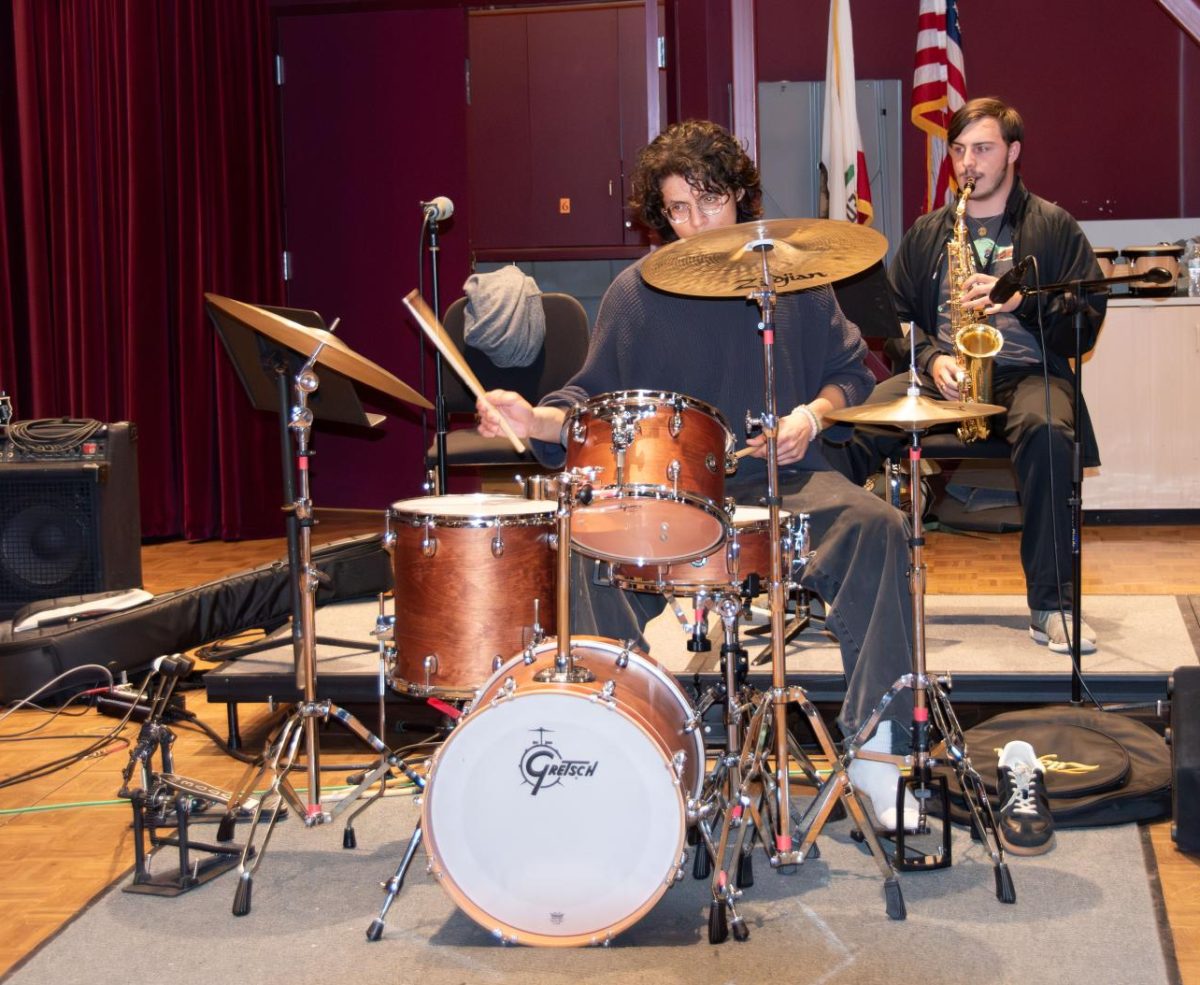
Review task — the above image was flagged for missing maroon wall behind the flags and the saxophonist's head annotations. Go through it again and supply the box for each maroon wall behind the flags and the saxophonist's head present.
[757,0,1200,226]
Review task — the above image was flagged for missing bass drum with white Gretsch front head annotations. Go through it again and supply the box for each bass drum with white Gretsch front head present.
[421,637,704,947]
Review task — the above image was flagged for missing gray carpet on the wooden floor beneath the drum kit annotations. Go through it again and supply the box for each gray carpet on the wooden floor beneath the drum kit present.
[10,797,1171,985]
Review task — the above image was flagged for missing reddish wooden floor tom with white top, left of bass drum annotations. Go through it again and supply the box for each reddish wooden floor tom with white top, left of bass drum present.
[388,493,557,698]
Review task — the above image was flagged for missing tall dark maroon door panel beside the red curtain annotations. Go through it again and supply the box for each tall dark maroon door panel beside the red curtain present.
[277,10,468,509]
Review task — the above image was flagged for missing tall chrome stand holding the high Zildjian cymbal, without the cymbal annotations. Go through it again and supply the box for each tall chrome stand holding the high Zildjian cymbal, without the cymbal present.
[709,238,906,943]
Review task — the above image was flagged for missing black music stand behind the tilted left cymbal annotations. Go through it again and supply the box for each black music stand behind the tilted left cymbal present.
[204,301,386,666]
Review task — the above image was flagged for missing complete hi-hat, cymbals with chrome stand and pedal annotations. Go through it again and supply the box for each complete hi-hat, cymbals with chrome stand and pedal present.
[827,360,1016,903]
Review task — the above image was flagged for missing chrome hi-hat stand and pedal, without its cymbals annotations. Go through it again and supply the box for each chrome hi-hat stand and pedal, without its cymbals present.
[846,371,1016,903]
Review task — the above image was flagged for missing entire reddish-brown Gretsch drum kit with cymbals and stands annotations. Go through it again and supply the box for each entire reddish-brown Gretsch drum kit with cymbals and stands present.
[204,220,1015,947]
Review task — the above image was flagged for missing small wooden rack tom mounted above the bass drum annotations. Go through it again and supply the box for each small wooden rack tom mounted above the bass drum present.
[566,390,733,564]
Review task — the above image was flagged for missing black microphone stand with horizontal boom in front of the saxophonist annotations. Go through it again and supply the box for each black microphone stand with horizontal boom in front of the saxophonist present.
[1020,266,1172,705]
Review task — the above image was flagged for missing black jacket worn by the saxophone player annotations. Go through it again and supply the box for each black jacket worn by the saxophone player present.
[888,175,1108,467]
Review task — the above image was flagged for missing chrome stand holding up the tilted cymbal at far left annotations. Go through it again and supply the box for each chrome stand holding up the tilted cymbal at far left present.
[217,346,416,917]
